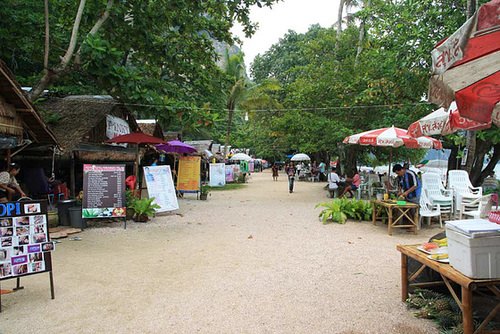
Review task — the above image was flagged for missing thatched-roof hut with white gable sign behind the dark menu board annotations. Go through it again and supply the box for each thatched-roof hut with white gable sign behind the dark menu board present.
[37,96,138,195]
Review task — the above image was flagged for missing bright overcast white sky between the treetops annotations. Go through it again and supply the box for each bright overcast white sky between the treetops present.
[233,0,339,74]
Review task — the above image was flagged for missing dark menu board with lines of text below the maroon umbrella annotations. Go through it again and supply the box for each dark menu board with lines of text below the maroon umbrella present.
[82,165,126,218]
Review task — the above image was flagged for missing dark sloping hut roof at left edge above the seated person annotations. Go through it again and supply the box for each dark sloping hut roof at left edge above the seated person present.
[0,60,57,148]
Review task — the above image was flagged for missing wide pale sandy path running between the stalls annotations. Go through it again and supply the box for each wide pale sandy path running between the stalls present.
[0,172,439,334]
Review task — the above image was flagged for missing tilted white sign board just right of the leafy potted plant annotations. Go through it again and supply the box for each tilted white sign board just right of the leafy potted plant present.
[144,165,179,212]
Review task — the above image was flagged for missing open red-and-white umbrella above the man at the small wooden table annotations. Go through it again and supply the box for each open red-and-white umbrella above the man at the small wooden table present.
[344,126,442,149]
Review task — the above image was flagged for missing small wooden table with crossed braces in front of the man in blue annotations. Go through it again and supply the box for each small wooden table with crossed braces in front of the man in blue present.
[371,199,419,235]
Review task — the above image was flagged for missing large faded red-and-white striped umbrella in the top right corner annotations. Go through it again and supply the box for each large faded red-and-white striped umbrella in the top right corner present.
[429,0,500,126]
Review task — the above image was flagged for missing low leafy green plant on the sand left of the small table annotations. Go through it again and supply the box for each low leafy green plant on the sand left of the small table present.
[316,197,372,224]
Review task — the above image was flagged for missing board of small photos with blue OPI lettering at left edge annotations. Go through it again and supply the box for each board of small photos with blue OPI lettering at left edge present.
[0,201,54,280]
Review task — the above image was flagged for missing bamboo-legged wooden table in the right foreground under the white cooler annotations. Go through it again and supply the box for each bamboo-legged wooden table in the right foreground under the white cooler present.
[397,245,500,334]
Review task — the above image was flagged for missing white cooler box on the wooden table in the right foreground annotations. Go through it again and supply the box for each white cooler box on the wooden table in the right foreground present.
[446,219,500,279]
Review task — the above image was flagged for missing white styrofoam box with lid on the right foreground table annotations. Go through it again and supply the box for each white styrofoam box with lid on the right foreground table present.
[446,224,500,278]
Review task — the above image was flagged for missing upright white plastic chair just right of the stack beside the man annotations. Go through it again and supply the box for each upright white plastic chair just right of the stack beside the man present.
[448,170,483,215]
